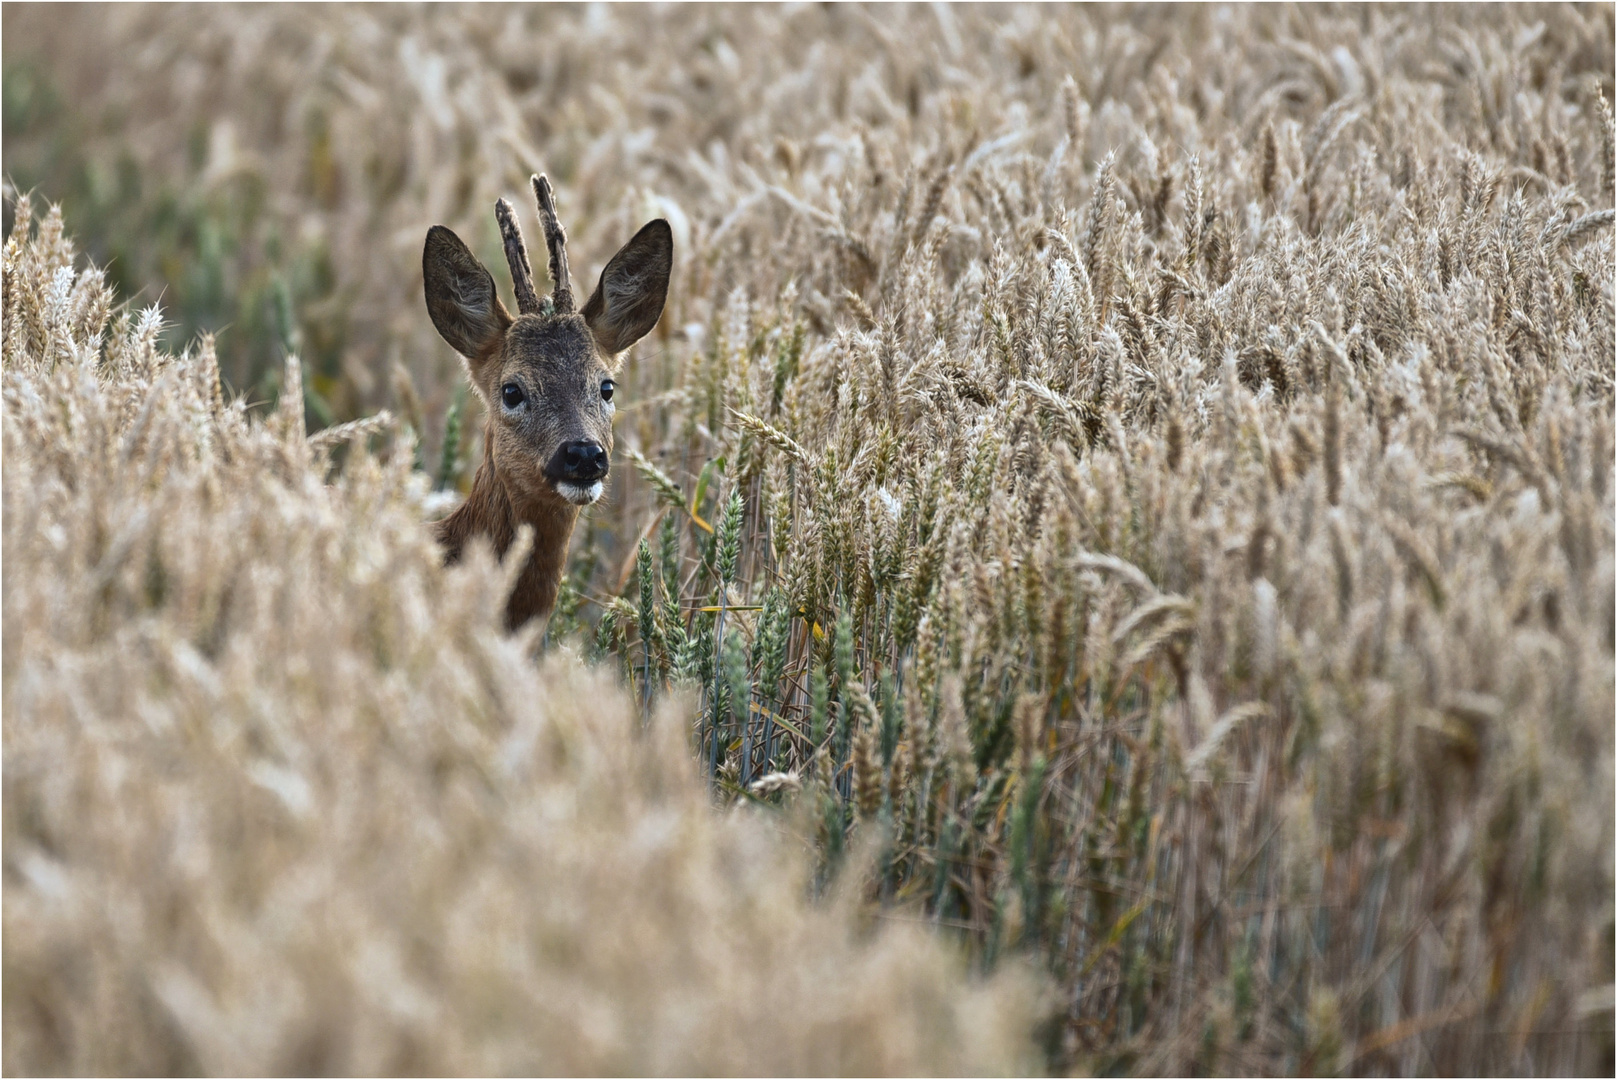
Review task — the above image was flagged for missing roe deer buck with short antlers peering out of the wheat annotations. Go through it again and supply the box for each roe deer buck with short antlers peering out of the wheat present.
[422,176,674,629]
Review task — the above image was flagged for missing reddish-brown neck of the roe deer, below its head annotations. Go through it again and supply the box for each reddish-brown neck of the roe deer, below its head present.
[437,428,579,631]
